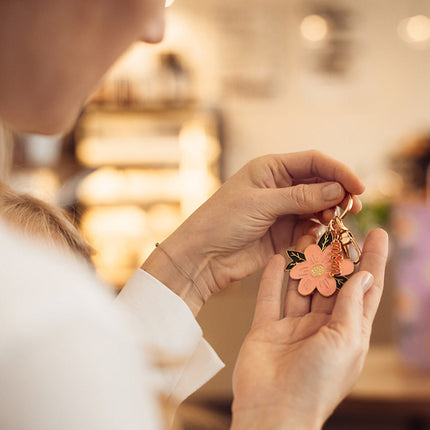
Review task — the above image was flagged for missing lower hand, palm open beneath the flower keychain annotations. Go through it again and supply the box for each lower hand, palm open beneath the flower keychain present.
[232,230,388,430]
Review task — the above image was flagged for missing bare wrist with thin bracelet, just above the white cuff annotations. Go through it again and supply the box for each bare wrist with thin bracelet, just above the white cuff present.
[141,233,212,316]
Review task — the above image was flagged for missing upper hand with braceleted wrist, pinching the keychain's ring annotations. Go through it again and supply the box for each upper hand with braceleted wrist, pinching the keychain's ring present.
[143,151,364,313]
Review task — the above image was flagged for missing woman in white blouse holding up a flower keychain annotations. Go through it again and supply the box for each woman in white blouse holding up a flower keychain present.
[0,0,387,430]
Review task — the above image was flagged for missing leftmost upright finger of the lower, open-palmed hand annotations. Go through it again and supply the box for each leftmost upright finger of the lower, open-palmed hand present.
[252,254,285,326]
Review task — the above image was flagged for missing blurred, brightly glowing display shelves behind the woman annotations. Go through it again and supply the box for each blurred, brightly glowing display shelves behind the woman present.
[74,104,221,289]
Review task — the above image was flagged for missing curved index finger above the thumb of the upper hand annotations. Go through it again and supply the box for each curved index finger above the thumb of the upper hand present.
[279,151,365,194]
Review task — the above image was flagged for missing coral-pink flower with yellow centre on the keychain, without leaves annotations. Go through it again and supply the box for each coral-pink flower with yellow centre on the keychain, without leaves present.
[290,245,354,297]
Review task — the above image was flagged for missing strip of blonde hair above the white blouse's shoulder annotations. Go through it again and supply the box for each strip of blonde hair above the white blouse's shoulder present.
[0,184,94,265]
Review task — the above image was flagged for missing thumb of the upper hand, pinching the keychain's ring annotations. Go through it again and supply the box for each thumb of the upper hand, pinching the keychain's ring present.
[264,182,345,216]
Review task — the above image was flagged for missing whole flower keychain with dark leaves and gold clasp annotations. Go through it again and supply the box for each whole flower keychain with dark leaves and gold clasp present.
[285,195,361,297]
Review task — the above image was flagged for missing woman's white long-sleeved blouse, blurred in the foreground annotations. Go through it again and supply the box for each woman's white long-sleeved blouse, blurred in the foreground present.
[0,224,223,430]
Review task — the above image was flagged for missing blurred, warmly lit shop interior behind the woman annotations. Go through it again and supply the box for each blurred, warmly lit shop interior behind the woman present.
[5,0,430,430]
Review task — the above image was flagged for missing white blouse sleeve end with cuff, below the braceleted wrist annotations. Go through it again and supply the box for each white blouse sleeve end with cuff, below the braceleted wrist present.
[117,269,224,403]
